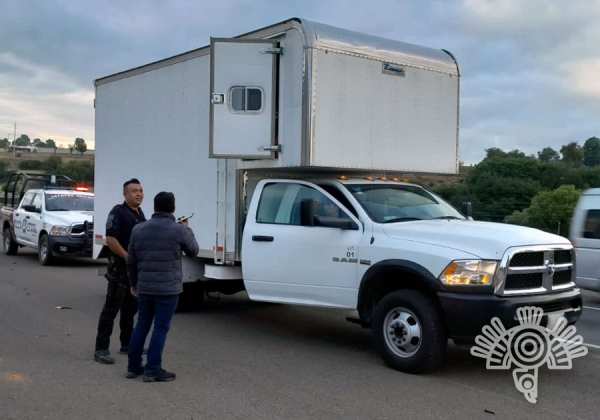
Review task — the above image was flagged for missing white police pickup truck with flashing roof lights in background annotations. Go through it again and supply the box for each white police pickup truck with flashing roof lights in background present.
[2,174,94,265]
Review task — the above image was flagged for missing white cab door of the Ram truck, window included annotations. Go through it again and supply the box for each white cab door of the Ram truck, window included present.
[242,180,364,309]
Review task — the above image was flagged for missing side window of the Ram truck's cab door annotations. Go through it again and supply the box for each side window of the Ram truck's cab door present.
[256,182,345,226]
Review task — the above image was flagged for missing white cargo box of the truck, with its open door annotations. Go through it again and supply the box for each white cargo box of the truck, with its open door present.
[94,19,460,263]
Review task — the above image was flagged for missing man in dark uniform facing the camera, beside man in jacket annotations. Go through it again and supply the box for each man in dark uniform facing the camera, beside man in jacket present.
[94,178,146,364]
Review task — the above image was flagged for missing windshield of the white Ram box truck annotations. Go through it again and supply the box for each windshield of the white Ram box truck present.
[345,184,465,223]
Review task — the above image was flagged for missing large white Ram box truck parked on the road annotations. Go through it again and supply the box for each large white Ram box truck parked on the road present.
[94,18,582,373]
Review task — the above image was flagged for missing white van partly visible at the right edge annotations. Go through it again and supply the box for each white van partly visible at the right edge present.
[569,188,600,292]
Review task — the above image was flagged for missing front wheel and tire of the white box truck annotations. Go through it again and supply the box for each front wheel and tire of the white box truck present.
[372,290,448,374]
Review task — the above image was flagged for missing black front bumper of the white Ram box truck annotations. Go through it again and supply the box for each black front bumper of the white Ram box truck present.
[438,288,583,344]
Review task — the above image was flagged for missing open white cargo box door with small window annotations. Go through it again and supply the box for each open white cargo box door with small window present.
[209,38,279,159]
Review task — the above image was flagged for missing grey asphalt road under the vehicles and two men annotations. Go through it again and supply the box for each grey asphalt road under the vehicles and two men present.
[0,250,600,420]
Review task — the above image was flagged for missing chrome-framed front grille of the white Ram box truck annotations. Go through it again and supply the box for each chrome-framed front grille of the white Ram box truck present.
[495,245,575,295]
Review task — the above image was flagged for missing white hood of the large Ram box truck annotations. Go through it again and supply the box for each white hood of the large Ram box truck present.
[383,220,571,260]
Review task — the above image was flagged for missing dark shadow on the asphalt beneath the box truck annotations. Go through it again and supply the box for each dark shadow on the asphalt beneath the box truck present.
[183,293,502,381]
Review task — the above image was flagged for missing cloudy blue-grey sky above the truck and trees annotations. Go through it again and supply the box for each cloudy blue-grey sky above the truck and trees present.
[0,0,600,163]
